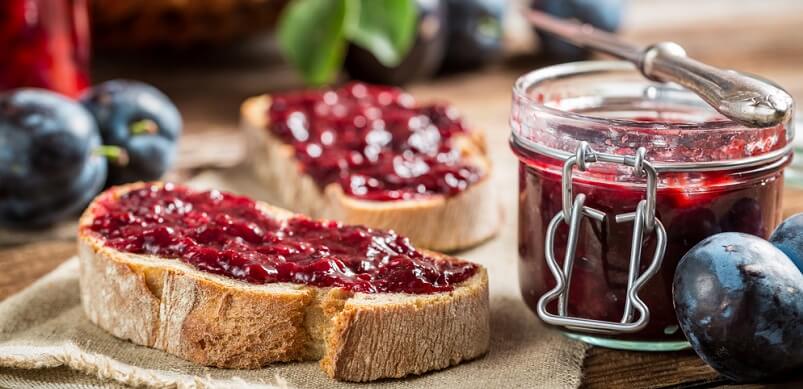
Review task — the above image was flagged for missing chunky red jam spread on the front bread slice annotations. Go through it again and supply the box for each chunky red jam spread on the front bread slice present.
[85,184,477,294]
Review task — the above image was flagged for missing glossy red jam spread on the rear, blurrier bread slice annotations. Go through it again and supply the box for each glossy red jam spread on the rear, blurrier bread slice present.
[268,83,481,201]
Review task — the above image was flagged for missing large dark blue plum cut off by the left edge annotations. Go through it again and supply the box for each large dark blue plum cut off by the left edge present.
[0,89,106,227]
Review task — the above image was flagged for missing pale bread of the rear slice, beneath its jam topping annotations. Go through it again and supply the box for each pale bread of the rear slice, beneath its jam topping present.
[241,95,502,251]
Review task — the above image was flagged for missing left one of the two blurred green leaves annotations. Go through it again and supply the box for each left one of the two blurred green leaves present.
[277,0,348,85]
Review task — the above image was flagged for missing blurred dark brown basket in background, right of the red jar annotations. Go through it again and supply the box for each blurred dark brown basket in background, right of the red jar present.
[89,0,289,49]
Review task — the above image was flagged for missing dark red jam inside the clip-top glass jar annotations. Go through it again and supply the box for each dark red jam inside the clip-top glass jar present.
[513,142,787,341]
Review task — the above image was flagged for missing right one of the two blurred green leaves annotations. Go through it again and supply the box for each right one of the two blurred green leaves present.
[346,0,418,67]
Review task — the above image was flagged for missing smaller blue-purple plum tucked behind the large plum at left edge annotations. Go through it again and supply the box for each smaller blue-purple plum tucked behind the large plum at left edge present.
[81,80,182,185]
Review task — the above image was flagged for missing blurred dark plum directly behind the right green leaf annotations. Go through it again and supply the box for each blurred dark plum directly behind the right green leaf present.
[345,0,448,85]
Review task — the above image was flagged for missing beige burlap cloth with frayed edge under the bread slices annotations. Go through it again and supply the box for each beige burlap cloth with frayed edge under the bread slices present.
[0,165,586,388]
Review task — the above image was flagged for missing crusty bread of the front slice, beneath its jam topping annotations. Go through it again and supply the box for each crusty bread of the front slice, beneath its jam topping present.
[78,183,490,381]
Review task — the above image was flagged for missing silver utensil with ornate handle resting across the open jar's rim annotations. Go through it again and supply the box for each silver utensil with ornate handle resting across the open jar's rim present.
[525,10,794,127]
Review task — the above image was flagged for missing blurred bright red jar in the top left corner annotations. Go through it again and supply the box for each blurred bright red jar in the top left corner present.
[0,0,89,97]
